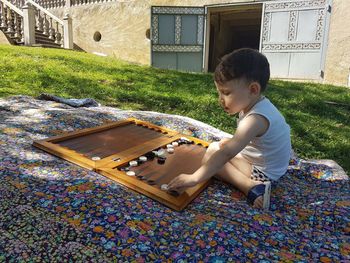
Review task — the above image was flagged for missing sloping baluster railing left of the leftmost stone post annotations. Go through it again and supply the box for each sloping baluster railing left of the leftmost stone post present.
[0,0,24,42]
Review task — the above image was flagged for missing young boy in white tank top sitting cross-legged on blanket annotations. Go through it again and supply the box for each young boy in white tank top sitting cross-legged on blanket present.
[168,48,291,210]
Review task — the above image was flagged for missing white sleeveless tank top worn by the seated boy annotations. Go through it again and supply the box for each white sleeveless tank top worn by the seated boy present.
[237,97,291,180]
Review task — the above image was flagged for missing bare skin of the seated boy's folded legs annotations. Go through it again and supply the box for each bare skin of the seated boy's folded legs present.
[202,143,263,208]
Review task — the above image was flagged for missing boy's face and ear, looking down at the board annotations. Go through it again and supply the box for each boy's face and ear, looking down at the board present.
[215,79,260,115]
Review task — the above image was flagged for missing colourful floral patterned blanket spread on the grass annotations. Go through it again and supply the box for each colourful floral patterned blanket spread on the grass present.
[0,96,350,262]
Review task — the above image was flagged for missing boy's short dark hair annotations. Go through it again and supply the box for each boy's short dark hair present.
[214,48,270,92]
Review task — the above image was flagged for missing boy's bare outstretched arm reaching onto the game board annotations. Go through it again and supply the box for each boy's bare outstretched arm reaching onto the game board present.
[169,114,269,189]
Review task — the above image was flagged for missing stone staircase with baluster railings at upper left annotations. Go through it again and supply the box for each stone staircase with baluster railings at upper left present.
[0,0,73,49]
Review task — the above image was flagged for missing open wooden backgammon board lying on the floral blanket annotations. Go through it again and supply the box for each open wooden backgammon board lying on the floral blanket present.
[33,118,209,210]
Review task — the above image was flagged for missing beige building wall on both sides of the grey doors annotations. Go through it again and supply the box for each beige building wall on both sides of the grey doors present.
[50,0,350,85]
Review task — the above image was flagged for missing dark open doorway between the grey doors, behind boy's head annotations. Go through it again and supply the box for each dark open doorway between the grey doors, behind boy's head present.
[208,4,262,72]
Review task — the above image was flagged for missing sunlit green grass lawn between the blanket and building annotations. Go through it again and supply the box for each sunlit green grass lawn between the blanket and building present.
[0,45,350,172]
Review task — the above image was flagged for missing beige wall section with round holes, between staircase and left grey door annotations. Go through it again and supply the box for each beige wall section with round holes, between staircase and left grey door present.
[50,0,253,64]
